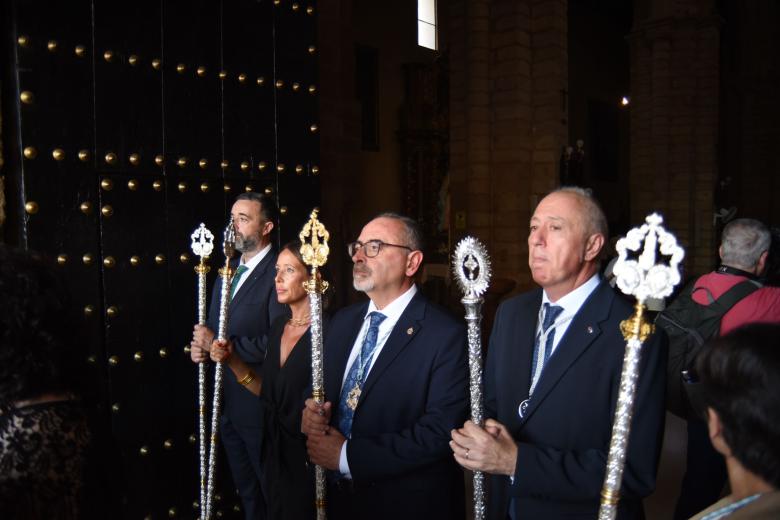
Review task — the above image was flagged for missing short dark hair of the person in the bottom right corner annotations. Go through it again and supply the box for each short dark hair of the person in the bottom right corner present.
[696,323,780,488]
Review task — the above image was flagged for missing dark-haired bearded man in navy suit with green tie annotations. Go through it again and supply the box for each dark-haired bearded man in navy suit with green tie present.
[190,192,285,520]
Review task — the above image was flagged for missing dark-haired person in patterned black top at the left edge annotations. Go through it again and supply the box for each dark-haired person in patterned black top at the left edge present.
[0,245,90,520]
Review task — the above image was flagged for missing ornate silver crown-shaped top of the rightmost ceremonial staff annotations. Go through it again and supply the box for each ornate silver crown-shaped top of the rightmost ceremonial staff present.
[613,213,685,303]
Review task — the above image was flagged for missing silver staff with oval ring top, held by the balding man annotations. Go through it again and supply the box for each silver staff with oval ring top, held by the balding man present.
[452,237,490,520]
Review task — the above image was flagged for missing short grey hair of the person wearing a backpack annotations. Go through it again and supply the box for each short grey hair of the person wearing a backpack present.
[720,218,772,270]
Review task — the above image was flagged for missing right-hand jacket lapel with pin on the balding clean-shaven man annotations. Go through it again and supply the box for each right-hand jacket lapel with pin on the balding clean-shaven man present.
[522,281,614,422]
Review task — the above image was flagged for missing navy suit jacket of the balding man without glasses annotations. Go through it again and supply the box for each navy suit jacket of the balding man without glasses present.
[485,281,667,520]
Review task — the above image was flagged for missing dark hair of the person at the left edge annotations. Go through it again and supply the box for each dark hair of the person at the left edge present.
[0,244,83,408]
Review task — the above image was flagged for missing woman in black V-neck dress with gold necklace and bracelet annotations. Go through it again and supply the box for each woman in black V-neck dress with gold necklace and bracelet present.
[211,242,316,520]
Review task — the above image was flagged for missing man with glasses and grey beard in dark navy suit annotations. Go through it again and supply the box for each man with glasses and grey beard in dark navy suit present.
[302,213,468,520]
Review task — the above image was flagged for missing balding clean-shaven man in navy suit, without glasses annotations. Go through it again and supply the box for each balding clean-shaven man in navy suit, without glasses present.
[451,188,666,520]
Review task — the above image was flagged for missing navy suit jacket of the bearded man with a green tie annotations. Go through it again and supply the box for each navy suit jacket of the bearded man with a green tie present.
[206,247,287,428]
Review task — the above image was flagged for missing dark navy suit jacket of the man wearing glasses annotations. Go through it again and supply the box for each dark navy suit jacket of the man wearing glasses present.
[325,292,468,520]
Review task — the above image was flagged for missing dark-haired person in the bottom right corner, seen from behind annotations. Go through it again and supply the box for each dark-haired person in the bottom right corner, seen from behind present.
[693,324,780,520]
